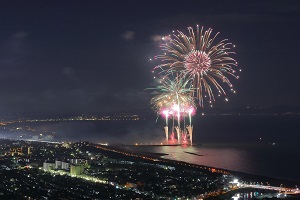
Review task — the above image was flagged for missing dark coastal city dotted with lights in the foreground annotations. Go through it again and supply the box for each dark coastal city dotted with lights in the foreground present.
[0,139,299,199]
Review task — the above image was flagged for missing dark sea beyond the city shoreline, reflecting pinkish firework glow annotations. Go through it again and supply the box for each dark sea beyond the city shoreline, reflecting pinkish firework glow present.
[0,115,300,181]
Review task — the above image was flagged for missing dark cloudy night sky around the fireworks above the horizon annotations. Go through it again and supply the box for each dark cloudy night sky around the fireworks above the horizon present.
[0,0,300,112]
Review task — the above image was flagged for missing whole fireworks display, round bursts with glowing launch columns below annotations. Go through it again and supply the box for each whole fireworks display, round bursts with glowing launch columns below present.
[150,25,241,144]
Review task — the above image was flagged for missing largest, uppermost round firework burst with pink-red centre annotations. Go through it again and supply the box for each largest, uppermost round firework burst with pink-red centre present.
[155,25,239,107]
